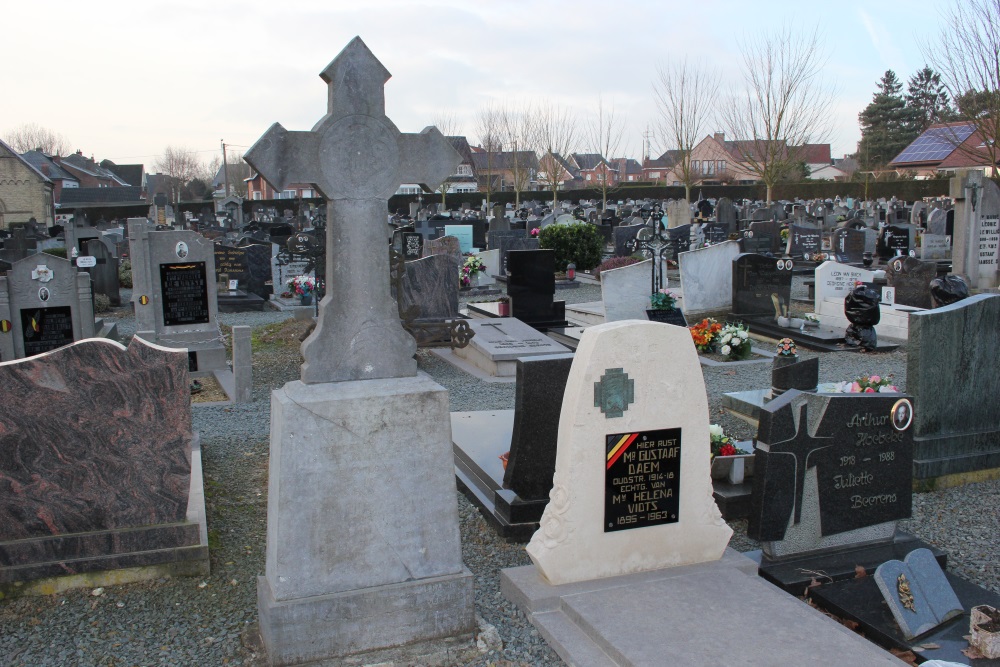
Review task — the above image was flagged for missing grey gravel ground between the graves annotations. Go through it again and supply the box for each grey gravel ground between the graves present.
[0,279,1000,667]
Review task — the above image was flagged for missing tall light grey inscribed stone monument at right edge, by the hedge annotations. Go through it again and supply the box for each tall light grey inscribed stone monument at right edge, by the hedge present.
[948,171,1000,289]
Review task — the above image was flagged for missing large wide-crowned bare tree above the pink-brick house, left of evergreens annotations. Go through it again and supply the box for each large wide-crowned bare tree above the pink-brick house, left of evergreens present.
[719,26,835,201]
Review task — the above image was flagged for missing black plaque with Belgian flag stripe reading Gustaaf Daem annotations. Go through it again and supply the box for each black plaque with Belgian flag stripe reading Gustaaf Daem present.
[604,428,681,533]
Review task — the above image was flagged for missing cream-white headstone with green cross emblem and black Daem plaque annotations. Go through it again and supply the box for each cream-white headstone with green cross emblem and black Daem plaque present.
[527,321,732,584]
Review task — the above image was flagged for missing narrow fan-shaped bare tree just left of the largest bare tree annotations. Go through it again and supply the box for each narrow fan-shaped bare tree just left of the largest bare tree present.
[653,58,719,201]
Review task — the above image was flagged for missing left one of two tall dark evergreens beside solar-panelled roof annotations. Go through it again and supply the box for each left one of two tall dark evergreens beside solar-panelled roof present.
[858,70,920,169]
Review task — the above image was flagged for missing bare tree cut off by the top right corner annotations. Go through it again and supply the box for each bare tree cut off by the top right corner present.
[921,0,1000,183]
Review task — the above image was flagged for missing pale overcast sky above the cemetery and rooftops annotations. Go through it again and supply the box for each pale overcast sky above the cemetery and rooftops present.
[0,0,941,169]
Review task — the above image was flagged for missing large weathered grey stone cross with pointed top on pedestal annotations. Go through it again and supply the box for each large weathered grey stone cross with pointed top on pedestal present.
[244,37,461,384]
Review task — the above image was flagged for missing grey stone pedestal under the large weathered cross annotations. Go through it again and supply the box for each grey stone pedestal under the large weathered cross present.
[257,374,475,665]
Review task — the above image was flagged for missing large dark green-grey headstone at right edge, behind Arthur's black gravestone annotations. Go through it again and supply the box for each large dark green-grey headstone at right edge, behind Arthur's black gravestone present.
[906,294,1000,485]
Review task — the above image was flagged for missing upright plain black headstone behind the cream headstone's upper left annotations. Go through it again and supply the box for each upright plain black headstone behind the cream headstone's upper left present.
[507,250,566,328]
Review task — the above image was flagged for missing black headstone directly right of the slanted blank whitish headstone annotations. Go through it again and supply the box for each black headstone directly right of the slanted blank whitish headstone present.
[733,254,793,318]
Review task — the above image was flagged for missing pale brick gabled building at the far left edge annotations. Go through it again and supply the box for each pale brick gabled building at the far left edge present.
[0,140,55,229]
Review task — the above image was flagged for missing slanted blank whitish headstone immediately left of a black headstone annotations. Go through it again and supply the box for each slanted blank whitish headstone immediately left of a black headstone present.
[679,241,740,320]
